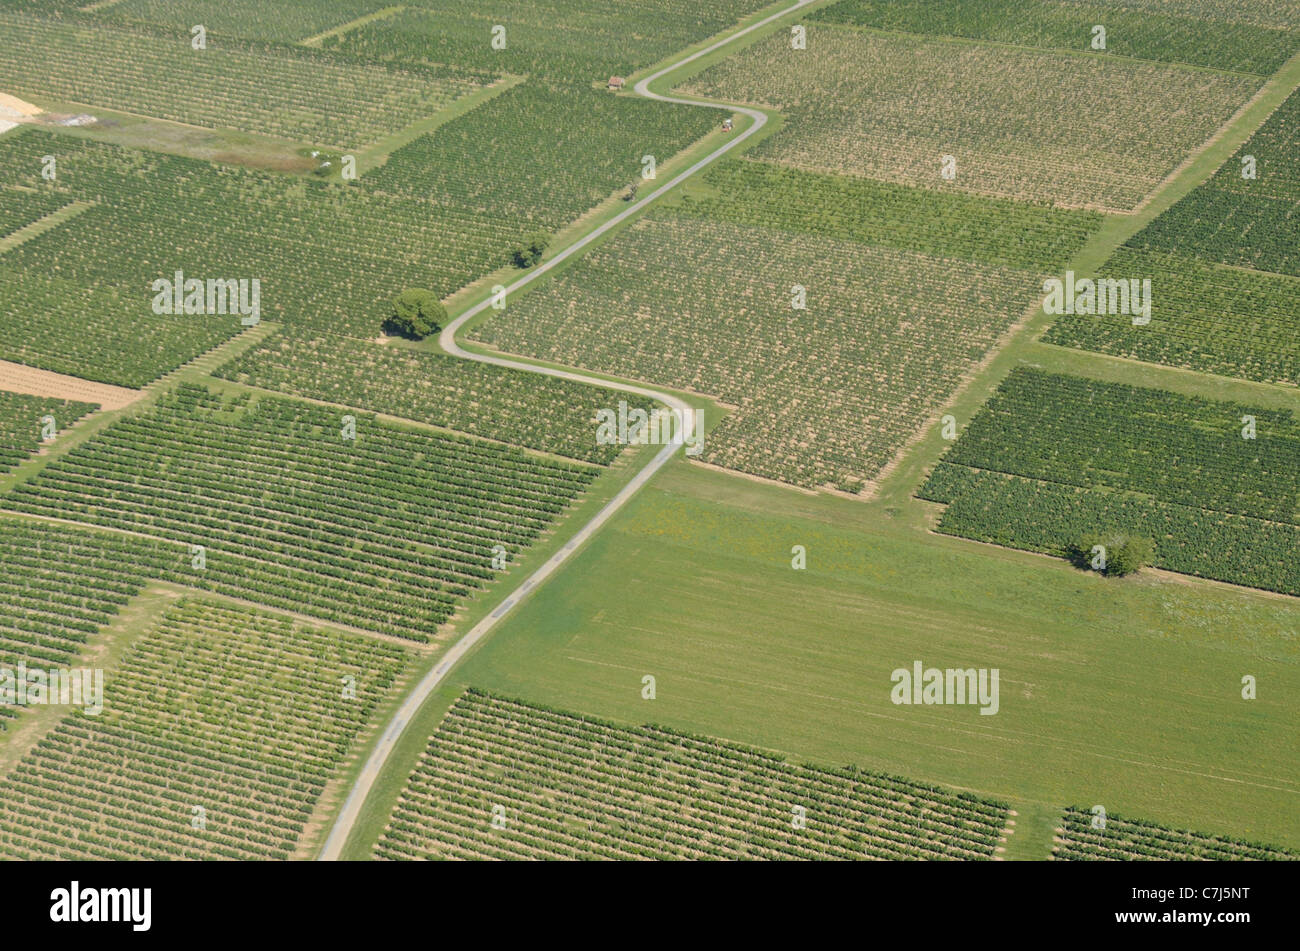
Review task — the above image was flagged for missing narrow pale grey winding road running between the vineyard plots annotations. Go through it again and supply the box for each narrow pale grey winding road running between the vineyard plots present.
[319,0,814,861]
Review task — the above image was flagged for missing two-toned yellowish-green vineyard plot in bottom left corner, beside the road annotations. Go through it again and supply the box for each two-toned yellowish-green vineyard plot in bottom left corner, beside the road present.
[0,600,408,860]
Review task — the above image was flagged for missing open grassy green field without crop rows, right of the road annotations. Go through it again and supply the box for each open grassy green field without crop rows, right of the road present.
[359,465,1300,857]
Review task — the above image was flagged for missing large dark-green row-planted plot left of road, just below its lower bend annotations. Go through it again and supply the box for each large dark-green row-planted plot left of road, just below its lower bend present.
[4,385,598,640]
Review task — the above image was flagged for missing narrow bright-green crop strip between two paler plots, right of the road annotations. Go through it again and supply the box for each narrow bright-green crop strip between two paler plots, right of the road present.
[679,160,1101,272]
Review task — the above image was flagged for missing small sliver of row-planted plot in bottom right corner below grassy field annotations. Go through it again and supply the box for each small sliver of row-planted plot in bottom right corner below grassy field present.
[1052,807,1300,861]
